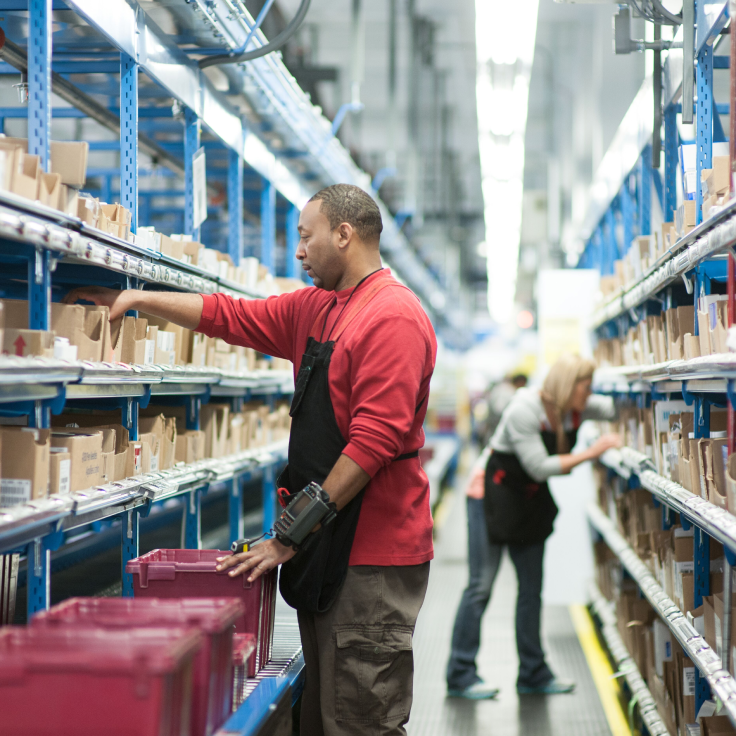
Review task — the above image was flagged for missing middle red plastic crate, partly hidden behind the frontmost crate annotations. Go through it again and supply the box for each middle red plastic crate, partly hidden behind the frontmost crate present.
[31,598,243,736]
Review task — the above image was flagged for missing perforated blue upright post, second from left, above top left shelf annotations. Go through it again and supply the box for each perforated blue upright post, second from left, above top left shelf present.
[120,52,138,233]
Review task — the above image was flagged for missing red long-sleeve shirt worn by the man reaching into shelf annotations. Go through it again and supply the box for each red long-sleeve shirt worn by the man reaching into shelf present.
[197,269,437,566]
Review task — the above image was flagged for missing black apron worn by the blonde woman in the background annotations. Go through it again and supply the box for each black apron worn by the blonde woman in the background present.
[483,426,578,544]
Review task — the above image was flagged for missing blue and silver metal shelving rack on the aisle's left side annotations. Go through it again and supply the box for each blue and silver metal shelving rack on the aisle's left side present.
[0,0,448,736]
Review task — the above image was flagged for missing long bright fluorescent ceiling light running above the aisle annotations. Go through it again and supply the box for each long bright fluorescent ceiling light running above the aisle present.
[475,0,539,324]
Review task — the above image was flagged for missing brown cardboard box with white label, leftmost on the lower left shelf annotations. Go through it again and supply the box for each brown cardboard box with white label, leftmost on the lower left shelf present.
[0,426,51,507]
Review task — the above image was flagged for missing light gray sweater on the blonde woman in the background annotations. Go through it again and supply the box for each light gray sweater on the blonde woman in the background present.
[490,388,616,483]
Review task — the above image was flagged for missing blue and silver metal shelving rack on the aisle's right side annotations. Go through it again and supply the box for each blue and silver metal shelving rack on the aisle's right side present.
[578,0,736,724]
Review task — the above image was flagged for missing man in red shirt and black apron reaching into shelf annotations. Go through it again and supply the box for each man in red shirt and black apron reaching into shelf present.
[65,184,437,736]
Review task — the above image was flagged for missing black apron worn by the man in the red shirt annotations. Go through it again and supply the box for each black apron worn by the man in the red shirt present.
[277,274,419,613]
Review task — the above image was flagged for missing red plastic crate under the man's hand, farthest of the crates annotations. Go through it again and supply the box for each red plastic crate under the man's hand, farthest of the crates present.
[125,549,278,671]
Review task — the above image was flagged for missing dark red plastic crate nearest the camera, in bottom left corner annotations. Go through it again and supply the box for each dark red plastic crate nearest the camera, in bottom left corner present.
[0,626,202,736]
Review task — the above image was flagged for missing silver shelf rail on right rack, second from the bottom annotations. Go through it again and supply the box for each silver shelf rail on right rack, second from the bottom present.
[588,504,736,723]
